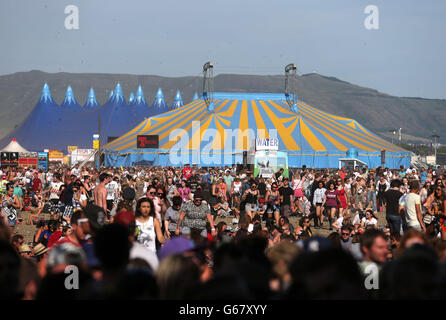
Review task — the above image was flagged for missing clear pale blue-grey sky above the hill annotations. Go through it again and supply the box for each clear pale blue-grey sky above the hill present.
[0,0,446,99]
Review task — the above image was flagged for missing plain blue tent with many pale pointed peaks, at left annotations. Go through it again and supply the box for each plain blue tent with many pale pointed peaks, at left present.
[0,83,183,151]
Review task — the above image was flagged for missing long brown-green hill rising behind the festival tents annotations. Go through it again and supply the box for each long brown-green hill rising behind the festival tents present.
[0,70,446,143]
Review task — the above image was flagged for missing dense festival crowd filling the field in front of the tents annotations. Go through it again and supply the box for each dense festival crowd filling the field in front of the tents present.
[0,164,446,300]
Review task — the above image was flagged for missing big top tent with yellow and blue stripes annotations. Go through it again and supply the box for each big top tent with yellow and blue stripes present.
[104,92,410,168]
